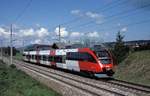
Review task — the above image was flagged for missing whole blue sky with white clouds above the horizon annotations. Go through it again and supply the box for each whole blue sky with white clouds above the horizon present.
[0,0,150,46]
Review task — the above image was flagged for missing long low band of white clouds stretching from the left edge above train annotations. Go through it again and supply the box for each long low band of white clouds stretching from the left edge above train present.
[0,27,103,47]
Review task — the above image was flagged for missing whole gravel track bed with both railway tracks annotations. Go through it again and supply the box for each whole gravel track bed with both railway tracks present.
[3,57,149,96]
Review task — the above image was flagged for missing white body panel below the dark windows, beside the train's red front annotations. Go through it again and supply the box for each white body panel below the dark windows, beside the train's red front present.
[66,60,80,71]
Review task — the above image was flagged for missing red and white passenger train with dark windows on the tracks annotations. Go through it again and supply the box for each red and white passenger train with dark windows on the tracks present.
[23,48,114,77]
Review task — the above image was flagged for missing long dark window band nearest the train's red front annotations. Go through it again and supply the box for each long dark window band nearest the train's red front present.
[66,52,96,63]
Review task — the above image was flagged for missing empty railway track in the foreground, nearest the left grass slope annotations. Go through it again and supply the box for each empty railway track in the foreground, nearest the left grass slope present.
[13,60,125,96]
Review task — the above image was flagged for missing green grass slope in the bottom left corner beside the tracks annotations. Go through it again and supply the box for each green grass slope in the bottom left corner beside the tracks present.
[0,61,59,96]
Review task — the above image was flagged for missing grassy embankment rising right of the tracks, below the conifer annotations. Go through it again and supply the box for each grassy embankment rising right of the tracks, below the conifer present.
[114,50,150,86]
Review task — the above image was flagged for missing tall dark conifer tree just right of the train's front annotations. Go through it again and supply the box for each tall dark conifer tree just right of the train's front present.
[113,31,129,64]
